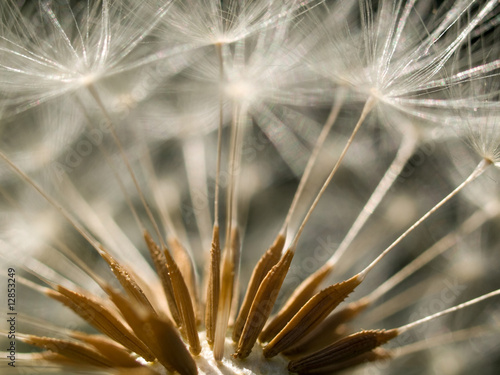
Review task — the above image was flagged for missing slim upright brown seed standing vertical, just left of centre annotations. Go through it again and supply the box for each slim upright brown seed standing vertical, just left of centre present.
[205,225,220,347]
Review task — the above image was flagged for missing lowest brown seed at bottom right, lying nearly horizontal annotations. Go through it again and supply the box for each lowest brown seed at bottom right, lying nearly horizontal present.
[288,329,398,372]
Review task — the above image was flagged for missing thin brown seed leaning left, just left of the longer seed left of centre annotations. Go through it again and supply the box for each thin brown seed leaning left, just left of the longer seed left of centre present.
[144,230,182,327]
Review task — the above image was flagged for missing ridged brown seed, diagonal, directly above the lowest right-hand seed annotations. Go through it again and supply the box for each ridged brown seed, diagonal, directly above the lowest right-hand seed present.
[263,275,361,358]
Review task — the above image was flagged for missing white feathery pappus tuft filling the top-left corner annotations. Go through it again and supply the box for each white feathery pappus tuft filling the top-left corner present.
[0,0,170,113]
